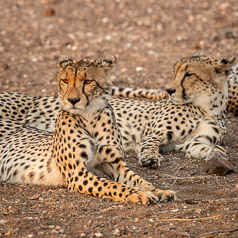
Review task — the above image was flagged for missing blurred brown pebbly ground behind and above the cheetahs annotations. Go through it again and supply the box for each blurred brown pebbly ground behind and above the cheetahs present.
[0,0,238,95]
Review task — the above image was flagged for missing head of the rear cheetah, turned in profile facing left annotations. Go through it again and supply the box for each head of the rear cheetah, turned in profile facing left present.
[166,54,235,113]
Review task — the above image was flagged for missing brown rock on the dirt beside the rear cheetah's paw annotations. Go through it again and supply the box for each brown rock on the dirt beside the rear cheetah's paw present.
[204,158,235,176]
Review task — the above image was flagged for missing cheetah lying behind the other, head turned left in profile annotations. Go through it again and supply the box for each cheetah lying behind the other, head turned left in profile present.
[0,55,235,168]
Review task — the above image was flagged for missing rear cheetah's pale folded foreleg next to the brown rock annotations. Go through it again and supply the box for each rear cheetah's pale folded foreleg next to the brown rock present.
[176,137,227,161]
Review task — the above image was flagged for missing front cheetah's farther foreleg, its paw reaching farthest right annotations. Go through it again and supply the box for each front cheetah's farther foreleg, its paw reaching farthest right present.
[96,145,175,202]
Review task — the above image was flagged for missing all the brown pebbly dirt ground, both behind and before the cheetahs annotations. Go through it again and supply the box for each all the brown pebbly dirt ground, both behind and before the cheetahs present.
[0,0,238,237]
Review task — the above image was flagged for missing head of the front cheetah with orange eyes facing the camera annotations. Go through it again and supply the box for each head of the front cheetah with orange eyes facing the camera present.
[57,55,116,115]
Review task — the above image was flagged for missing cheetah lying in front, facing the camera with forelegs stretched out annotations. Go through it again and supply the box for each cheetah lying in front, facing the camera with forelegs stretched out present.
[0,56,175,204]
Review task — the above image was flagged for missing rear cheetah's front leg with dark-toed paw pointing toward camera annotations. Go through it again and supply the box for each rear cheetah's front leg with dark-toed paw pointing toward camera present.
[137,135,163,169]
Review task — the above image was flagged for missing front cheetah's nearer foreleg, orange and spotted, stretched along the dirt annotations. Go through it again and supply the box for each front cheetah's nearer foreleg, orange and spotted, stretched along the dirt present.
[55,138,162,204]
